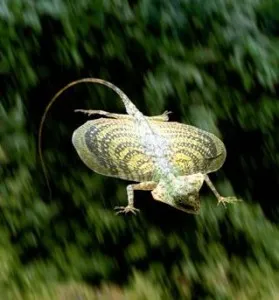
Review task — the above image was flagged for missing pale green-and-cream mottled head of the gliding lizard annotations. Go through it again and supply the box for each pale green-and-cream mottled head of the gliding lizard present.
[151,173,204,213]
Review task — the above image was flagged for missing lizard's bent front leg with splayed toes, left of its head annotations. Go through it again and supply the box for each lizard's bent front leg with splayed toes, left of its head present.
[114,181,157,215]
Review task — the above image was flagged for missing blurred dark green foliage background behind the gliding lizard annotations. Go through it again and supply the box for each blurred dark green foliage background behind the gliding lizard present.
[0,0,279,300]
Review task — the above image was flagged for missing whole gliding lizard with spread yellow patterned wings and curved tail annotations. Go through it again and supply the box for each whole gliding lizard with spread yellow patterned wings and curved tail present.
[38,78,240,214]
